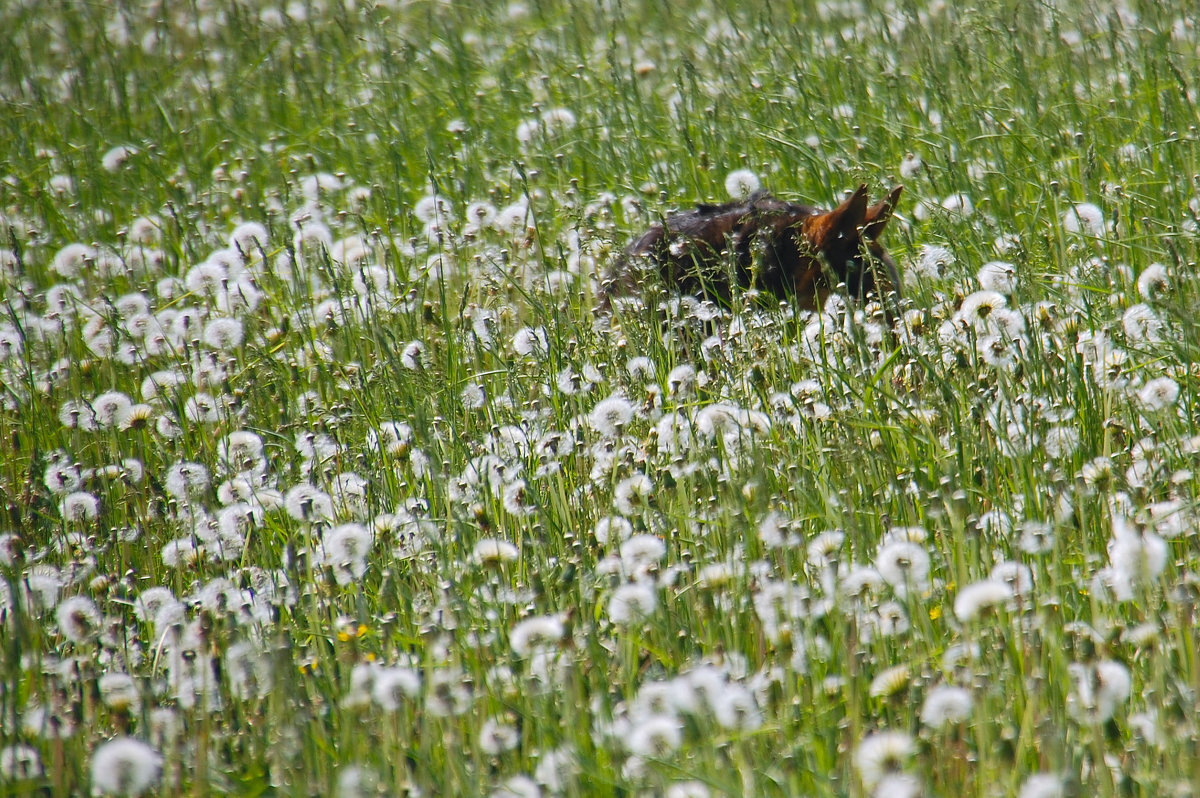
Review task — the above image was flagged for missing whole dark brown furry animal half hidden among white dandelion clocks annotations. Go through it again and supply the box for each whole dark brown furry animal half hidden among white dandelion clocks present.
[602,185,901,316]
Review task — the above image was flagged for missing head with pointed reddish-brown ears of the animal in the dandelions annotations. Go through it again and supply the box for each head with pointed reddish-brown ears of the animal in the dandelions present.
[800,185,904,299]
